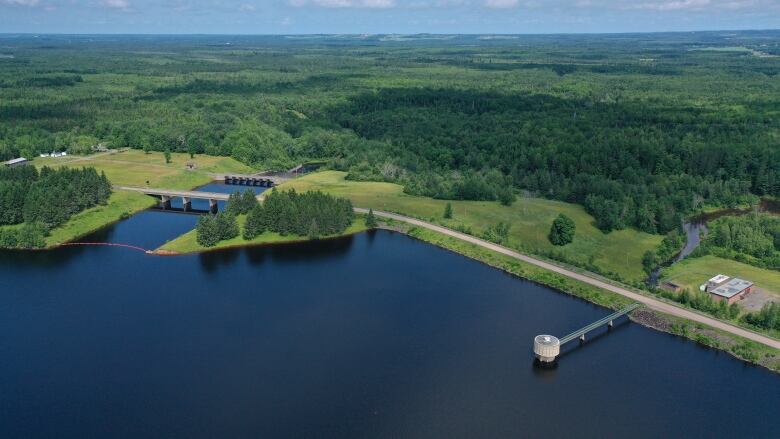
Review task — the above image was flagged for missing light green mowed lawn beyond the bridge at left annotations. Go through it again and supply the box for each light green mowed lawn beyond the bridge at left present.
[33,150,256,189]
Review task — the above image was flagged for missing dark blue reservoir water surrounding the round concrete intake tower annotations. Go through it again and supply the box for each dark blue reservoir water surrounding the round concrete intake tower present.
[0,212,780,438]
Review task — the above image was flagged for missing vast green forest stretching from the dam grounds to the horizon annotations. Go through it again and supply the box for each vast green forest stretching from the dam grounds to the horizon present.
[0,31,780,237]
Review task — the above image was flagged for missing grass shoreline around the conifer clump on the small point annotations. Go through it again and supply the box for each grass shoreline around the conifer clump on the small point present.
[157,215,367,254]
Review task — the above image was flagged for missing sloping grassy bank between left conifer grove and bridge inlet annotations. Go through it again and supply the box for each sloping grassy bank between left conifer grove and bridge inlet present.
[46,191,156,247]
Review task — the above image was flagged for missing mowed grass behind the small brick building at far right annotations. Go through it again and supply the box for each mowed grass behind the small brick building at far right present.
[663,255,780,296]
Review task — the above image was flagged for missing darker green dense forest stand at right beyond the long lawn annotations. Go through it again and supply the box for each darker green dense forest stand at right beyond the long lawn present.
[333,88,780,233]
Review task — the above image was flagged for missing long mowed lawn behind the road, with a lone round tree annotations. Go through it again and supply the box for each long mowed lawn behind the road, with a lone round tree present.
[280,171,662,281]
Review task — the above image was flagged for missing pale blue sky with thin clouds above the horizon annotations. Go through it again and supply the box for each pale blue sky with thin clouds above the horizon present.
[0,0,780,34]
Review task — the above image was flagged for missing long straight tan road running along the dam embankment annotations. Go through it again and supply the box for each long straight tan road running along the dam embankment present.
[355,208,780,349]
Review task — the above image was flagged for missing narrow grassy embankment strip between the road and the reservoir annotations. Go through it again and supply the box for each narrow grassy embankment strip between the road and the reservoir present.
[391,222,780,372]
